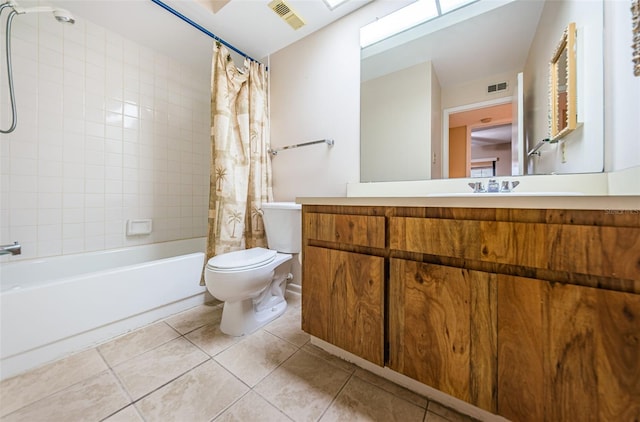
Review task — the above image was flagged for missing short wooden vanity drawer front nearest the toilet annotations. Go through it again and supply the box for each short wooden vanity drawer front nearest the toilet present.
[304,213,385,248]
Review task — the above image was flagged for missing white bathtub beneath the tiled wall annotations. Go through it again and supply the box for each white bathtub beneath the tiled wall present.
[0,238,206,379]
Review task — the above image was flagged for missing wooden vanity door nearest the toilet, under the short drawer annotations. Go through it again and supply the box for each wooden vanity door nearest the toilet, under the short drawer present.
[302,246,384,366]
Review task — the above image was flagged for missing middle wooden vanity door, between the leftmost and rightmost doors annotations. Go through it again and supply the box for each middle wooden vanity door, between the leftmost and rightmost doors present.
[389,259,496,412]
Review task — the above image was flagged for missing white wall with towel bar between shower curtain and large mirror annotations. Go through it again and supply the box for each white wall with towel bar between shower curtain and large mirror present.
[269,1,410,201]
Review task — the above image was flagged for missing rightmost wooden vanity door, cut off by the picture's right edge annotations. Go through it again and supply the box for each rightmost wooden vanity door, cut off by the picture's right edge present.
[498,276,640,421]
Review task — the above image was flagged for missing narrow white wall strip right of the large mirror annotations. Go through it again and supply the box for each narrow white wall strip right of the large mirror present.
[604,0,640,172]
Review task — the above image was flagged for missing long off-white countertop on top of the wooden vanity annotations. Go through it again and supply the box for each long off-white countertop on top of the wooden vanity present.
[296,193,640,210]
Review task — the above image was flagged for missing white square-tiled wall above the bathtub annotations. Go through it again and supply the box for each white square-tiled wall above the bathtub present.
[0,11,210,262]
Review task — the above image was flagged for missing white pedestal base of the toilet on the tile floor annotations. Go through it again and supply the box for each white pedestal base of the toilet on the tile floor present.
[220,296,287,337]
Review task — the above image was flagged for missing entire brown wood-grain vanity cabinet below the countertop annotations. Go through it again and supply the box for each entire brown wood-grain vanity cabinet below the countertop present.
[302,206,640,421]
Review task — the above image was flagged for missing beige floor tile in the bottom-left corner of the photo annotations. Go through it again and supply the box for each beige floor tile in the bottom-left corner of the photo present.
[2,371,129,422]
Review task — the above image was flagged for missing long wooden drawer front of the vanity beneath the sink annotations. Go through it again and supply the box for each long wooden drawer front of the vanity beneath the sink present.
[389,217,640,281]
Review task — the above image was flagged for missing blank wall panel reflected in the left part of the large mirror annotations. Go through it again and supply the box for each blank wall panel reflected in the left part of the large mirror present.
[360,62,432,182]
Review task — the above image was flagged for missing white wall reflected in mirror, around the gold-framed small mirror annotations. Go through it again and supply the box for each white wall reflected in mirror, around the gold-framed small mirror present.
[524,0,610,174]
